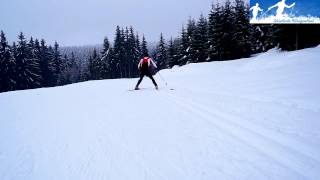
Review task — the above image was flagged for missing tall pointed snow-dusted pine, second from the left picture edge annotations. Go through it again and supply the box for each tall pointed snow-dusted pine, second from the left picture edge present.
[15,32,41,90]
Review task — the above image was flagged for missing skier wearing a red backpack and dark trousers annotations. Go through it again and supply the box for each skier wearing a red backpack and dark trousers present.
[135,54,158,90]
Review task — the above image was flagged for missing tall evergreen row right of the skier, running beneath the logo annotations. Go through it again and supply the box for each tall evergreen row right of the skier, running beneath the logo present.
[149,0,320,68]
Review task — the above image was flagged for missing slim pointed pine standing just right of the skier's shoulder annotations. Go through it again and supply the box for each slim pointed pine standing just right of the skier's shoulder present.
[155,33,168,70]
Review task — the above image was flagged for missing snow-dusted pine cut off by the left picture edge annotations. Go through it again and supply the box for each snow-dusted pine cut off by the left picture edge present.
[0,31,16,92]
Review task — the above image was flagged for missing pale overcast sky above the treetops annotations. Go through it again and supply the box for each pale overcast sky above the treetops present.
[0,0,220,46]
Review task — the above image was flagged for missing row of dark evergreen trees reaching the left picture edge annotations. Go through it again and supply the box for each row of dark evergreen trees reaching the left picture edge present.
[0,31,79,92]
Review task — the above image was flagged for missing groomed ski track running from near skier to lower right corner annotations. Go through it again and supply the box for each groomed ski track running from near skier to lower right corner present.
[159,89,320,179]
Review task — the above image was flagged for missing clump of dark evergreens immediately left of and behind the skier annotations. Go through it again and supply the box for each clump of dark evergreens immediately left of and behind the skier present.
[88,26,148,80]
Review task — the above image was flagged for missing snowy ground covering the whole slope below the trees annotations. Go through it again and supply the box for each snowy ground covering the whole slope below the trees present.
[0,47,320,180]
